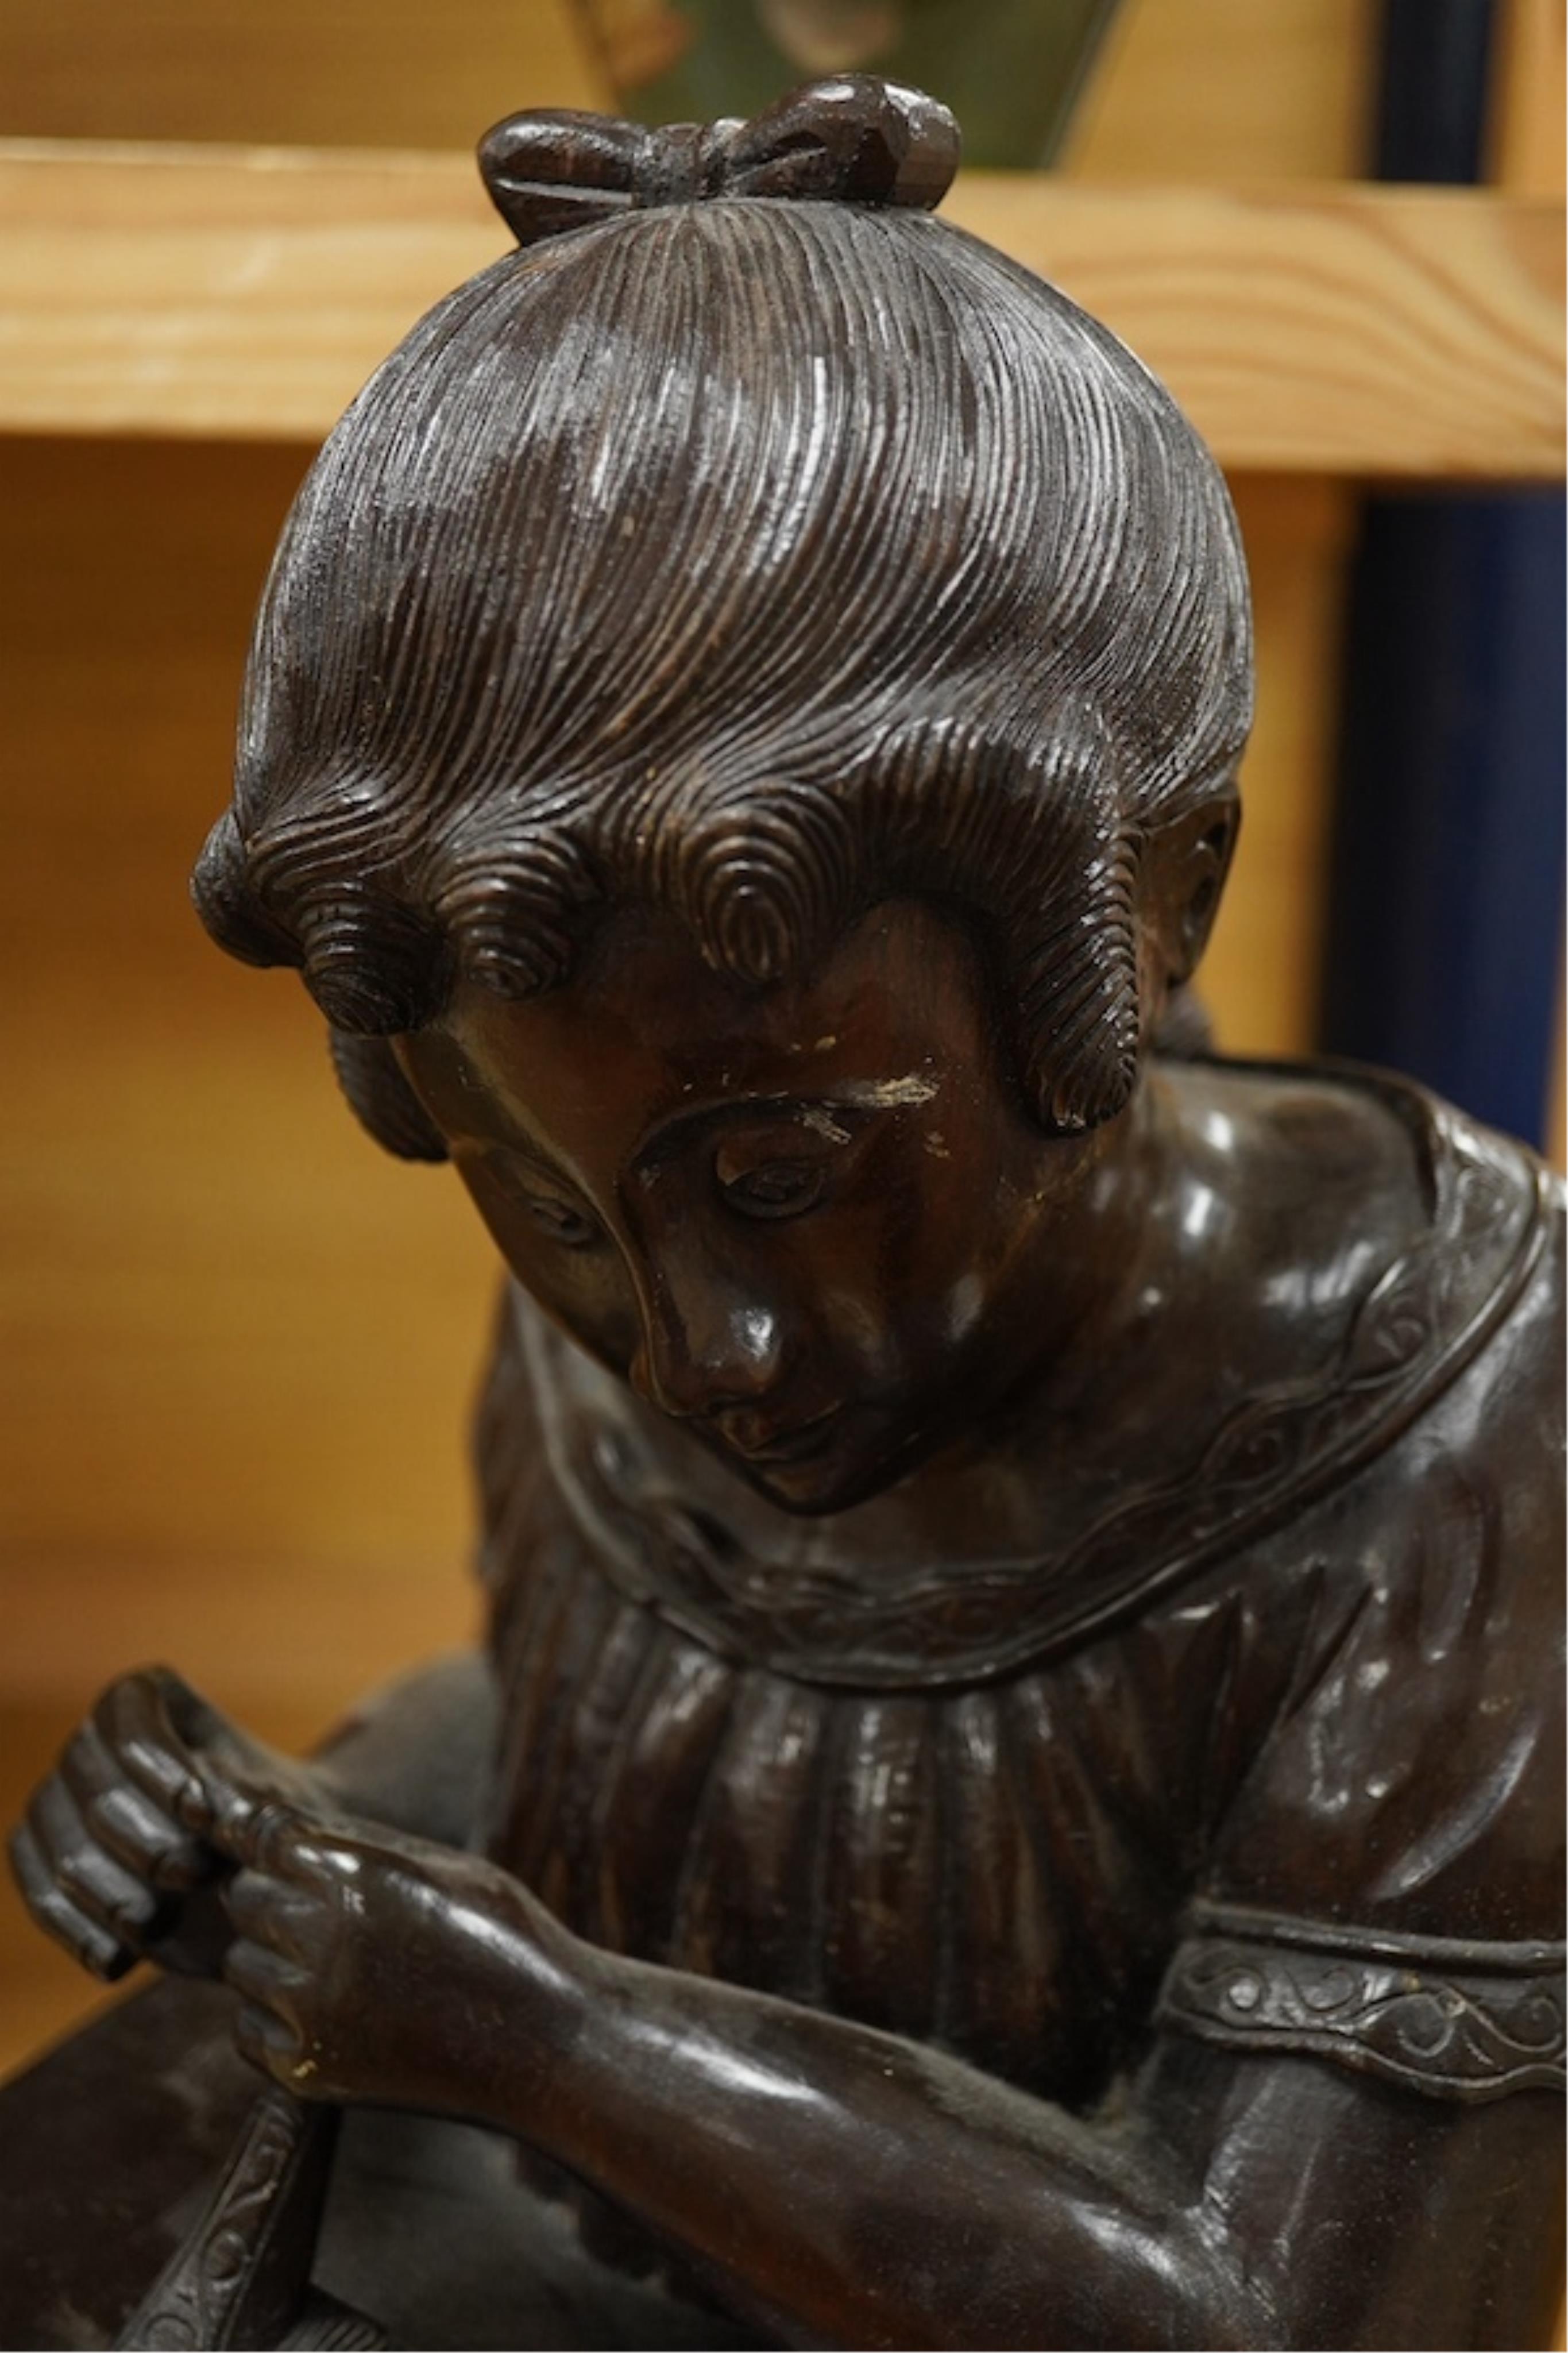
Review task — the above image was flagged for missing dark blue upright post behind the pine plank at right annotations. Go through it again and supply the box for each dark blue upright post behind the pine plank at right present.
[1321,0,1566,1141]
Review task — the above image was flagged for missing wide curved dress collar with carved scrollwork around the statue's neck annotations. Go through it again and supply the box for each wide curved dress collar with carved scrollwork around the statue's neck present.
[512,1066,1547,1689]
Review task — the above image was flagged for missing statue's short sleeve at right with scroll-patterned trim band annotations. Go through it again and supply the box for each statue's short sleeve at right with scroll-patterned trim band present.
[1164,1089,1563,2099]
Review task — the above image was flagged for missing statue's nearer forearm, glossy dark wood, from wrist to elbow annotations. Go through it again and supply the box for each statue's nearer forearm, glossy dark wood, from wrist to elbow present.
[486,1955,1276,2346]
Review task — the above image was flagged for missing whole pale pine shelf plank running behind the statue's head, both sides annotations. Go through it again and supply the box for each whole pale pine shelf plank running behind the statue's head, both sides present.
[0,141,1563,480]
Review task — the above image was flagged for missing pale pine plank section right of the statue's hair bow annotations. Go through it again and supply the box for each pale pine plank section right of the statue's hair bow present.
[947,174,1563,480]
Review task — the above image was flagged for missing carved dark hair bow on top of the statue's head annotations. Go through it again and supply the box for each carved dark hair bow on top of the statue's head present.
[480,73,959,245]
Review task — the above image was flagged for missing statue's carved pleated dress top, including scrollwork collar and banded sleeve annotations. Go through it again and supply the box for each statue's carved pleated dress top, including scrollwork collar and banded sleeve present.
[480,1078,1563,2136]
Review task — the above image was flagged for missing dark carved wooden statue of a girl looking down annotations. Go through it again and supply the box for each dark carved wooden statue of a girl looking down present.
[7,78,1563,2346]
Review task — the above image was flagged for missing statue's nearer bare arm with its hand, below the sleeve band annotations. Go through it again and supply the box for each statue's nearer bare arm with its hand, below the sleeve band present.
[211,1786,1551,2346]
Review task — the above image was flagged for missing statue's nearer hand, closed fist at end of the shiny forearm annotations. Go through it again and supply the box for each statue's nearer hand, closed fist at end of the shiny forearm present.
[209,1779,583,2130]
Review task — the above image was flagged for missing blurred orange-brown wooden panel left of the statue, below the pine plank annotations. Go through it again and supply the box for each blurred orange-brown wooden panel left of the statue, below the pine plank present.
[0,442,494,2066]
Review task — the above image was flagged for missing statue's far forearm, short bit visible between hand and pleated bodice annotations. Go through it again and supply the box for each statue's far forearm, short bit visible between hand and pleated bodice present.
[312,1649,499,1847]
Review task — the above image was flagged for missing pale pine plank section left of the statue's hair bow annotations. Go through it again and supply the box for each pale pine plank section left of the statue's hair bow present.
[0,144,508,440]
